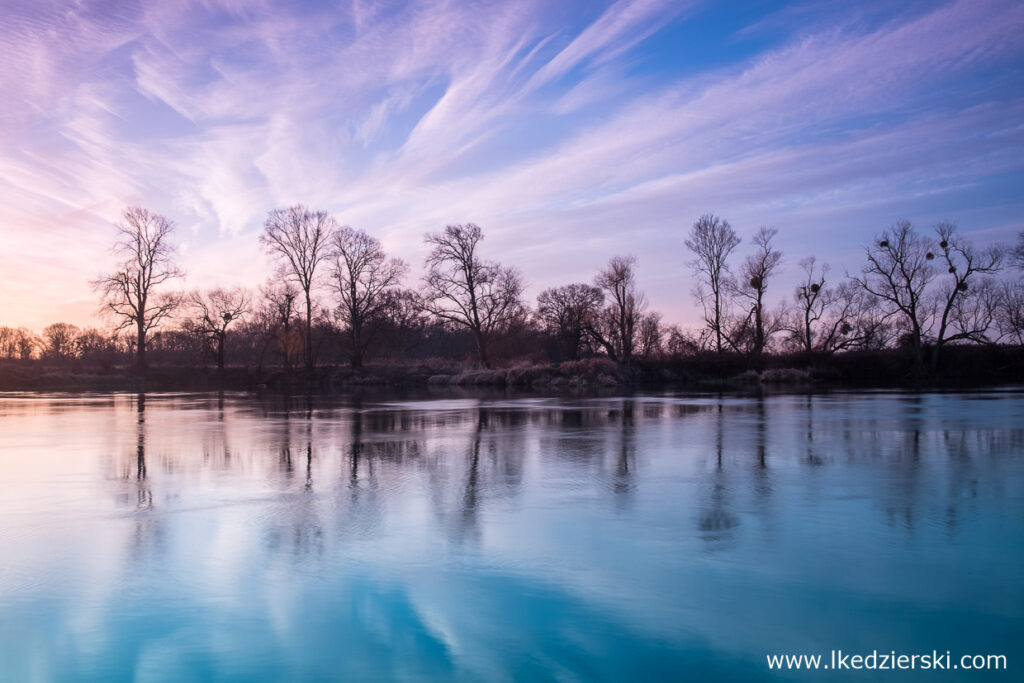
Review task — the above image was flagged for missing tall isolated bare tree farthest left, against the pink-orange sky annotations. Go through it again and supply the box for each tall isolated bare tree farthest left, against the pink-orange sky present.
[92,207,183,374]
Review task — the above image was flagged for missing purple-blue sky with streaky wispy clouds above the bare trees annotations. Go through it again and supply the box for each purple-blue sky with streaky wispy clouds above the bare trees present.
[0,0,1024,331]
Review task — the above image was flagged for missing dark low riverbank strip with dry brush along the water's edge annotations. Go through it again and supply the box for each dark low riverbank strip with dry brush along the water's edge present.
[0,346,1024,393]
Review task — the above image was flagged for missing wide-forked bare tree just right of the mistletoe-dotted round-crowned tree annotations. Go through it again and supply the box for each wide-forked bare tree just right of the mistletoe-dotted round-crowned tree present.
[925,221,1004,370]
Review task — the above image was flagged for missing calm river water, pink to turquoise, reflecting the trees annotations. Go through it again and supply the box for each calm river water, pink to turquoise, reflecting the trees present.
[0,391,1024,681]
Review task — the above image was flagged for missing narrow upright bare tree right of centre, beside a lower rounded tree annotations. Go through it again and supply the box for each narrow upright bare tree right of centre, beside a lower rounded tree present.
[591,256,647,366]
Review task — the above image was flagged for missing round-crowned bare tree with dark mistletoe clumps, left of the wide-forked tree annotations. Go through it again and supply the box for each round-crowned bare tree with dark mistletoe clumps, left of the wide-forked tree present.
[852,220,935,370]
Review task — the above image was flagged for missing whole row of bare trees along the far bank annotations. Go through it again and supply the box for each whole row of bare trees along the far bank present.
[0,206,1024,385]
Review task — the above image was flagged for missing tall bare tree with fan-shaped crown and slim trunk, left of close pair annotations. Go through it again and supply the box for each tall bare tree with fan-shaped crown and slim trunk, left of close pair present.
[260,204,336,375]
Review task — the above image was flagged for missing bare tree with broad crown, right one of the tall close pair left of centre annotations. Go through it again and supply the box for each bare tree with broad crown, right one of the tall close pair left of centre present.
[331,226,409,368]
